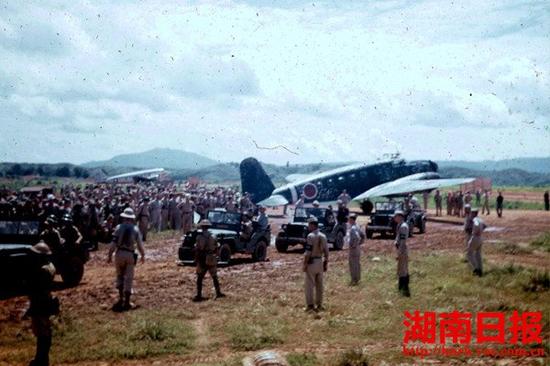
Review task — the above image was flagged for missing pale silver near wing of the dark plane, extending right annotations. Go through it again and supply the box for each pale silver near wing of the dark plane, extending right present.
[353,178,475,201]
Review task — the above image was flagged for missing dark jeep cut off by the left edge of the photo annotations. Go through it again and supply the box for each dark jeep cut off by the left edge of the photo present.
[0,220,89,289]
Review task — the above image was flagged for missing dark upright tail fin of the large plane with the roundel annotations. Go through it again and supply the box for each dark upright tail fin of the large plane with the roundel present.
[240,158,275,203]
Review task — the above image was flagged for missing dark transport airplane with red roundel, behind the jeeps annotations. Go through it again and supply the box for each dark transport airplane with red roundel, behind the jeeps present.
[240,158,474,206]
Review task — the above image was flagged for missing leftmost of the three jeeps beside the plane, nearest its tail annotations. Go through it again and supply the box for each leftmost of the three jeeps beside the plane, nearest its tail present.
[178,209,271,265]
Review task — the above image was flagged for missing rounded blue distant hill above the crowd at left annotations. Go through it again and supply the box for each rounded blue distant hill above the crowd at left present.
[82,149,218,170]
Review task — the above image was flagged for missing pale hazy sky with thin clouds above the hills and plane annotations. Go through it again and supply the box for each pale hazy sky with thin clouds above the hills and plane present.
[0,0,550,163]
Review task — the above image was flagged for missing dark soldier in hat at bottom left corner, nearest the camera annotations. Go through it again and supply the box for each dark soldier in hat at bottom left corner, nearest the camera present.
[27,241,59,366]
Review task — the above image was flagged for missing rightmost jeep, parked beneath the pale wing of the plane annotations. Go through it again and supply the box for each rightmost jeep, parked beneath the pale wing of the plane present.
[365,200,426,239]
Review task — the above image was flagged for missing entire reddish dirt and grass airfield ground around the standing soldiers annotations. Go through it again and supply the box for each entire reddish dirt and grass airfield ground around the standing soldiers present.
[0,211,550,366]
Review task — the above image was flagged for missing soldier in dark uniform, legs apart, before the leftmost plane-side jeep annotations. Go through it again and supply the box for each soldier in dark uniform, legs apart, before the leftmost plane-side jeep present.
[193,220,225,302]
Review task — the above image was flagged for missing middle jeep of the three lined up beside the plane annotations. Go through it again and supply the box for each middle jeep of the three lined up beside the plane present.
[275,207,346,253]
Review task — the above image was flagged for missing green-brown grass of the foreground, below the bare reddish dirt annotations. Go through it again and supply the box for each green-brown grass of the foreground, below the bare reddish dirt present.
[0,252,550,365]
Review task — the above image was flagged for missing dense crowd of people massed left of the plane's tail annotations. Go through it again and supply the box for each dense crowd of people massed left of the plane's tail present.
[0,183,256,248]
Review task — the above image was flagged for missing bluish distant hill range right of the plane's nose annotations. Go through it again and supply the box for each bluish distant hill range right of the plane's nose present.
[437,157,550,173]
